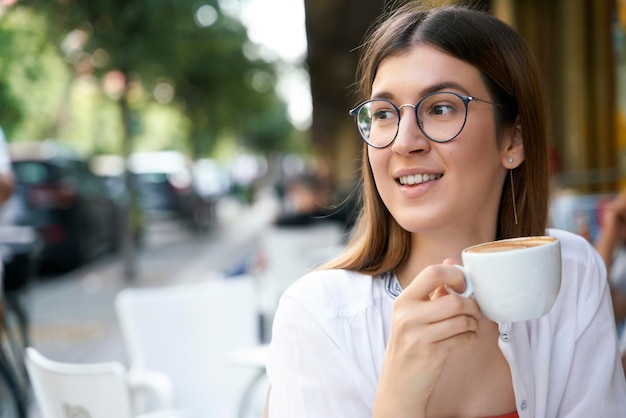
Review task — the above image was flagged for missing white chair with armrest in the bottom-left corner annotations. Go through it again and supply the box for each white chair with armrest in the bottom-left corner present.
[24,347,176,418]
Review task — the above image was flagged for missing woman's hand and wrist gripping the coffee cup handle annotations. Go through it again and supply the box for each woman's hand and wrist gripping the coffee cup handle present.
[374,259,481,417]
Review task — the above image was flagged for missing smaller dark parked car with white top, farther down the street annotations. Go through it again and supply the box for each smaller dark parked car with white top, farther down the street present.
[128,151,212,230]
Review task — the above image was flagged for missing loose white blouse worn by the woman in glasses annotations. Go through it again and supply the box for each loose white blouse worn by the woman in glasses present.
[267,229,626,418]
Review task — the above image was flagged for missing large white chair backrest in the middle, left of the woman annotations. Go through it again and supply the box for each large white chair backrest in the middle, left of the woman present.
[115,276,259,418]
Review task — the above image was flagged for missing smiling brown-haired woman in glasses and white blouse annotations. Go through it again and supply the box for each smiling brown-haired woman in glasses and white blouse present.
[267,4,626,418]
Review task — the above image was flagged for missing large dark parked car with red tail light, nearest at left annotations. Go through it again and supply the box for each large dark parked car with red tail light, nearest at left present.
[9,141,119,269]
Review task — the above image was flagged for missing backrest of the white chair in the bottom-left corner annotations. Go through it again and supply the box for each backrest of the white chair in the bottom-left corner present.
[25,347,133,418]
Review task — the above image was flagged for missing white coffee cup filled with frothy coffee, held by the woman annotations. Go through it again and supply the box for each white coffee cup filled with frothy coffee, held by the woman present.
[448,236,561,321]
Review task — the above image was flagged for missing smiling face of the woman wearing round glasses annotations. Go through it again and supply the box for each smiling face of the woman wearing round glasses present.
[368,45,523,235]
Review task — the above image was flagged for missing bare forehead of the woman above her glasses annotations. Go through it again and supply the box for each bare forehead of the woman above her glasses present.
[372,44,488,100]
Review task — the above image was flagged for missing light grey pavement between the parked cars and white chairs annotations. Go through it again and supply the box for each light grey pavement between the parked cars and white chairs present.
[19,195,275,418]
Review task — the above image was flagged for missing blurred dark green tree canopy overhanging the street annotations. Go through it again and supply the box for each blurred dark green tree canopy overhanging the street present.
[15,0,293,157]
